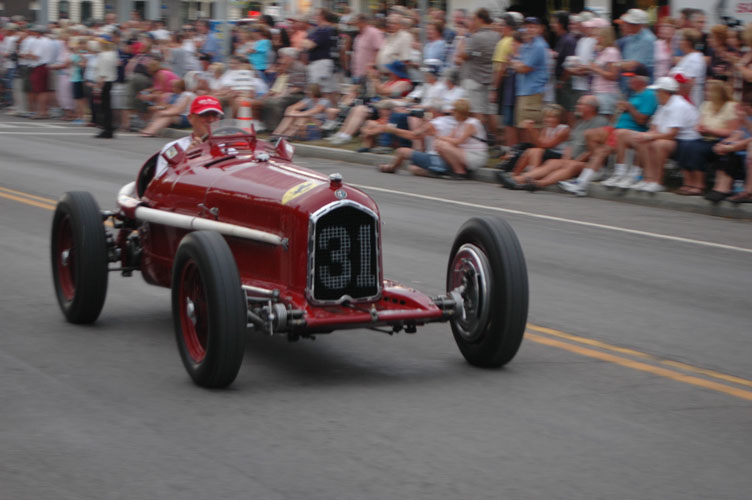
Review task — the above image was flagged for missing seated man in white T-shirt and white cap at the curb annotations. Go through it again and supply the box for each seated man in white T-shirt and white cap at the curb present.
[629,76,700,193]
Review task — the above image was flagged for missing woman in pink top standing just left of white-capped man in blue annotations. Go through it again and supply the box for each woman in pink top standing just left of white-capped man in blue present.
[589,26,621,116]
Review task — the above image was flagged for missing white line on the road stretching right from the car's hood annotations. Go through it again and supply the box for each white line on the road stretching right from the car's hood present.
[350,184,752,254]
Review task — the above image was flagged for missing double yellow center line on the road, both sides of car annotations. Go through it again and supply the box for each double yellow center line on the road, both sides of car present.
[0,186,752,401]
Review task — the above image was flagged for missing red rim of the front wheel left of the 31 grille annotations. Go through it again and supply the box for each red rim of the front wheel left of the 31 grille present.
[179,261,209,363]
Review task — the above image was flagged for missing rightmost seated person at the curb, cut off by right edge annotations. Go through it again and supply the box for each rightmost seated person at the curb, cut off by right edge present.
[705,100,752,203]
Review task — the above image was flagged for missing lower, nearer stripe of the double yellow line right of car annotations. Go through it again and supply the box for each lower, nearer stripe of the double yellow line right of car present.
[525,332,752,401]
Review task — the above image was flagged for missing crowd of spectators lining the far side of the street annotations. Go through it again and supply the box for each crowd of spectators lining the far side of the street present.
[0,6,752,203]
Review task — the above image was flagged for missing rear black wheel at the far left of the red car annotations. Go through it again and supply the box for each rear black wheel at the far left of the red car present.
[50,191,108,324]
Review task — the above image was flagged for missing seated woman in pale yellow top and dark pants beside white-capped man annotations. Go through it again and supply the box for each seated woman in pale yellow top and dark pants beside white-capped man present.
[676,80,740,196]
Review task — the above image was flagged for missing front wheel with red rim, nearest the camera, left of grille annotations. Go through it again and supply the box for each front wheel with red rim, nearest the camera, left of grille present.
[172,231,247,388]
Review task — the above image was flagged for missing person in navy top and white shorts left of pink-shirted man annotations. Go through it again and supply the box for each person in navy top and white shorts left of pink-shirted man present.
[303,9,336,97]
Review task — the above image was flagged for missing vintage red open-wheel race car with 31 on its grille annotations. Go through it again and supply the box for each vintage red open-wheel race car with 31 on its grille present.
[51,120,528,387]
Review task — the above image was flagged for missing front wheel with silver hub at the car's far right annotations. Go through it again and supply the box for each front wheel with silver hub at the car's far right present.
[447,217,528,368]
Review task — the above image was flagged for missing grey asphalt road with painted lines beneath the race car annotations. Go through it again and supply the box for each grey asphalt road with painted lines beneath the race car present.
[0,117,752,500]
